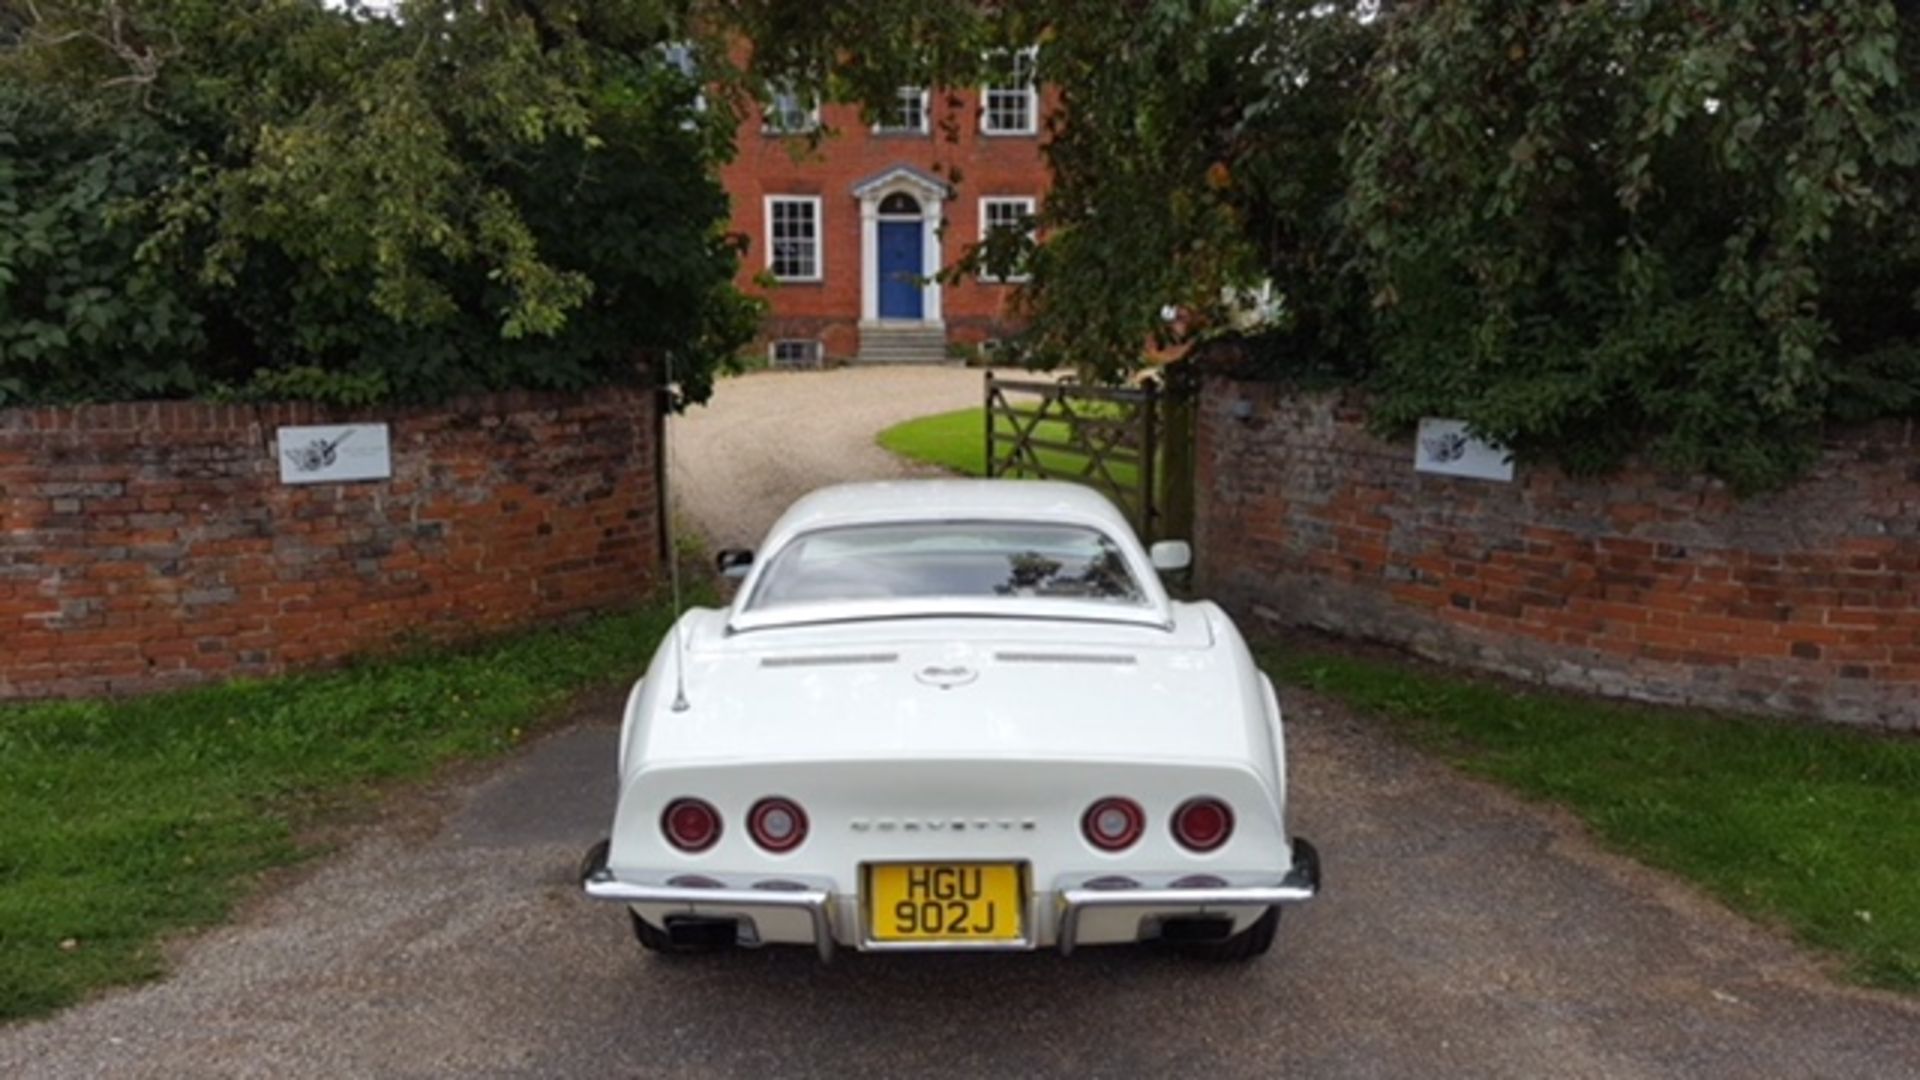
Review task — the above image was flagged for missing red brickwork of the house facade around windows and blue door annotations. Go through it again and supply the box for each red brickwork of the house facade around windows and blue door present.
[720,88,1052,359]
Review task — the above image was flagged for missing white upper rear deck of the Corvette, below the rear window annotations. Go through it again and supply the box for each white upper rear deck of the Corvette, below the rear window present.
[626,605,1269,769]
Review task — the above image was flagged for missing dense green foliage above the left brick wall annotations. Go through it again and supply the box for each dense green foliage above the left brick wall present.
[0,0,756,404]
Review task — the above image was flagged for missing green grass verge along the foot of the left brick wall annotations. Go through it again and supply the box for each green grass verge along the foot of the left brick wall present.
[0,607,668,1019]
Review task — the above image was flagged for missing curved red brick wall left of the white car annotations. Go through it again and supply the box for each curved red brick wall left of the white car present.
[0,390,659,698]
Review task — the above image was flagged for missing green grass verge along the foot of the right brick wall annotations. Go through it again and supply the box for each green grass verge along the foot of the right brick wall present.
[1265,650,1920,992]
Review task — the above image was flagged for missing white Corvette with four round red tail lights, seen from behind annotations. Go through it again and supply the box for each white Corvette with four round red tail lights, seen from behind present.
[582,480,1319,959]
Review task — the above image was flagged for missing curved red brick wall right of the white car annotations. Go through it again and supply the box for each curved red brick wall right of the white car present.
[1196,377,1920,730]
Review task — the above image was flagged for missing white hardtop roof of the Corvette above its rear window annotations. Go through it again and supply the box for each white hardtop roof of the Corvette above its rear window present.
[766,480,1133,550]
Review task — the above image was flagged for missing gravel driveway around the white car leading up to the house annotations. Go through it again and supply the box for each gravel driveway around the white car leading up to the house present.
[0,371,1920,1078]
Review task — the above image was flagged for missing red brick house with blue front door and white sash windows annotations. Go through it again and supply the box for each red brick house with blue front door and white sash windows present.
[722,54,1048,365]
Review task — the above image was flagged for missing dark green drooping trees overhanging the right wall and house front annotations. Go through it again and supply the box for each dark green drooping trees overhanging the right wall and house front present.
[722,0,1920,488]
